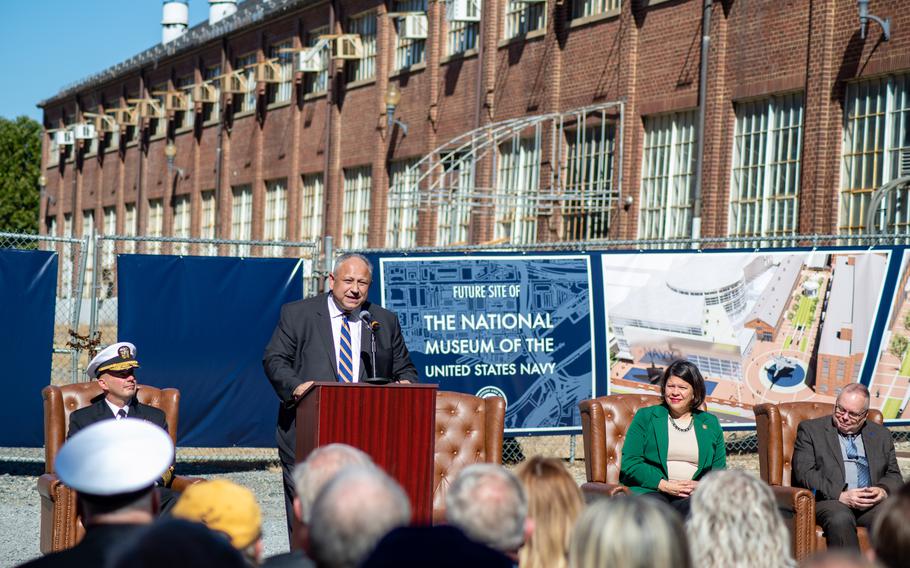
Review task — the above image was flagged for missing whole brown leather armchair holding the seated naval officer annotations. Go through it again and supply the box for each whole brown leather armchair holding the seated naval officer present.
[38,381,199,554]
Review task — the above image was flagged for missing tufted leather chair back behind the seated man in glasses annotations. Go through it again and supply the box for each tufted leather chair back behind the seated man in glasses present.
[753,402,882,487]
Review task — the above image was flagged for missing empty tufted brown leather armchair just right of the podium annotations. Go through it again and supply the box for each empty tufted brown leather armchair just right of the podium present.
[433,391,506,524]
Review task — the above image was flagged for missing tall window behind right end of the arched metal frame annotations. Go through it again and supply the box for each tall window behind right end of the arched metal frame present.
[563,123,618,240]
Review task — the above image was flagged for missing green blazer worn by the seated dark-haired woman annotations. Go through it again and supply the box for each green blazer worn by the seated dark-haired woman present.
[619,404,727,493]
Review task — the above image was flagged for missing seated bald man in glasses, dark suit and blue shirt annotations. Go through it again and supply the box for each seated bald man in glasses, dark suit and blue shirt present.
[793,383,903,550]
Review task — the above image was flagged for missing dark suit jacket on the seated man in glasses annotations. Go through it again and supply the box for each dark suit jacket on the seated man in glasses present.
[792,416,904,501]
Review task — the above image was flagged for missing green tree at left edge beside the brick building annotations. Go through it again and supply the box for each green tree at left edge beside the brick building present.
[0,116,41,233]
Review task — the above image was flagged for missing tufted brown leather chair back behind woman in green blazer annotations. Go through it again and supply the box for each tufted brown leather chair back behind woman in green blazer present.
[578,394,660,484]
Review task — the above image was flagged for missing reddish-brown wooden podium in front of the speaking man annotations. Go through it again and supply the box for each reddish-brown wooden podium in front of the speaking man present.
[296,382,437,525]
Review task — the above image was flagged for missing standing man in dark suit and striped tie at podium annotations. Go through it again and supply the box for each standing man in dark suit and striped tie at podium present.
[262,253,417,536]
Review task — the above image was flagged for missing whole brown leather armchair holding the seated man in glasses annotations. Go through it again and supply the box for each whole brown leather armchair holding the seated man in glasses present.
[753,402,882,560]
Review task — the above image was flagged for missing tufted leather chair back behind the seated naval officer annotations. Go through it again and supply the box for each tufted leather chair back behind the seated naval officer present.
[41,381,180,473]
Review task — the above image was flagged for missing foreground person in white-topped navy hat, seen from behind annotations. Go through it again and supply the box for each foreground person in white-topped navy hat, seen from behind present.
[17,419,174,568]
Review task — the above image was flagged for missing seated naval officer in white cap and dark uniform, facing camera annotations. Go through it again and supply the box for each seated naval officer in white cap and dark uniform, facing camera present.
[66,342,178,511]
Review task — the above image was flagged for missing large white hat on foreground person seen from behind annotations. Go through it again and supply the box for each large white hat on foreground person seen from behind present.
[55,418,174,496]
